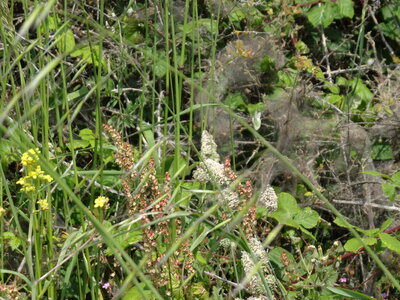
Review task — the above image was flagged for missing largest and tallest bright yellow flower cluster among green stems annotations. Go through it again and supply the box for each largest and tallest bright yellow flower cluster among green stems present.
[17,148,53,193]
